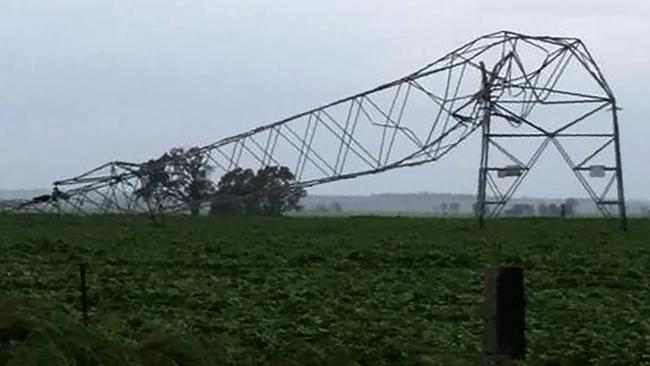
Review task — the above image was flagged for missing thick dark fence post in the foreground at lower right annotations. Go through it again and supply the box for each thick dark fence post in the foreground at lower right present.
[483,267,526,361]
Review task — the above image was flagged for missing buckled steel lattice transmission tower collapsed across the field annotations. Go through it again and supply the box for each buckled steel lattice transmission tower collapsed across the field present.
[13,31,626,228]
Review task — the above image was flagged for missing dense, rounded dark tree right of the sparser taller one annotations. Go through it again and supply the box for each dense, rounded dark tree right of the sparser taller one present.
[210,166,306,216]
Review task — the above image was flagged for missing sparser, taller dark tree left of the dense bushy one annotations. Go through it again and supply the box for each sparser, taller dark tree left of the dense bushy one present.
[135,147,214,215]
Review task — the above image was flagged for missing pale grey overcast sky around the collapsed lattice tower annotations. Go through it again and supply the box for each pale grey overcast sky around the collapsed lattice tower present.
[0,0,650,198]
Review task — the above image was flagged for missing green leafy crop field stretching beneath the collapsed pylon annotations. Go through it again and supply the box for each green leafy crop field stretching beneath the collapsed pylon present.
[0,215,650,365]
